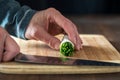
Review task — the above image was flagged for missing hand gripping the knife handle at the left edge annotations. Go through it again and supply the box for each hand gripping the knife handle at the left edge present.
[0,27,20,62]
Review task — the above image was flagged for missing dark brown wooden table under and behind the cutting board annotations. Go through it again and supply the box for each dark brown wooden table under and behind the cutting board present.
[0,15,120,80]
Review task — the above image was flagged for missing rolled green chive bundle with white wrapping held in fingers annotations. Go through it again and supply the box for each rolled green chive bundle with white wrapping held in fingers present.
[60,35,74,56]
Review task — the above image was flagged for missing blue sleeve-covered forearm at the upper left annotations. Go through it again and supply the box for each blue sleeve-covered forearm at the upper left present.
[0,0,35,39]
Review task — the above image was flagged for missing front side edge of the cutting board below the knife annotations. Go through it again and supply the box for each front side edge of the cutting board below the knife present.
[0,62,120,74]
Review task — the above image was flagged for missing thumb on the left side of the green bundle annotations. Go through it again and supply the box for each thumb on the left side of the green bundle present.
[34,27,60,50]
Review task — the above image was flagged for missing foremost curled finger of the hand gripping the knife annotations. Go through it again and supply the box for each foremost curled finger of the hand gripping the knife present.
[3,35,20,61]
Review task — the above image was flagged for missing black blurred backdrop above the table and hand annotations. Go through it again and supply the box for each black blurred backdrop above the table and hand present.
[17,0,120,14]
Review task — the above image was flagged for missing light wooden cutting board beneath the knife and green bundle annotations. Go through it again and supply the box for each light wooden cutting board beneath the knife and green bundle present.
[0,35,120,74]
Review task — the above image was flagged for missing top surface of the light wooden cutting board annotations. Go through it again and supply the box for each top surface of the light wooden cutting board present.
[14,34,120,61]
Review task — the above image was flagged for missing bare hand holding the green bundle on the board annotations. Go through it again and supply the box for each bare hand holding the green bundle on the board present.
[25,8,82,50]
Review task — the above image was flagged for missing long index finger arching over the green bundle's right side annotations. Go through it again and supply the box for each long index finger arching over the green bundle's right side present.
[50,8,82,50]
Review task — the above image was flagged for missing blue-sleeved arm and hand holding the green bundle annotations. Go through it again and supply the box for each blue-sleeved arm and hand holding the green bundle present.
[0,0,82,50]
